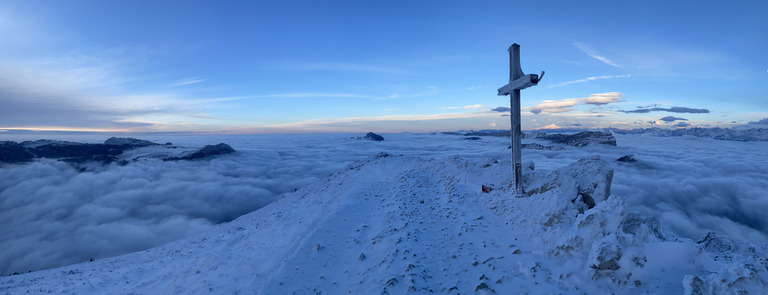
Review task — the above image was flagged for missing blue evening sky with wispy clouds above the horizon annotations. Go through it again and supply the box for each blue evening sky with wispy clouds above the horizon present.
[0,0,768,133]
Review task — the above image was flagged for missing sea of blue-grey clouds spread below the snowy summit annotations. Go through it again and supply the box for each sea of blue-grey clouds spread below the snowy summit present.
[0,133,768,274]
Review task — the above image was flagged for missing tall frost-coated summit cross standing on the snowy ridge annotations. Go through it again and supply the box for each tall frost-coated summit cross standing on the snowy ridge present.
[499,43,544,194]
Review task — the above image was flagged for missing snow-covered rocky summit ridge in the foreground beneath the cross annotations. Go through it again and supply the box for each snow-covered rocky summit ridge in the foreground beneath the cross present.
[0,153,768,294]
